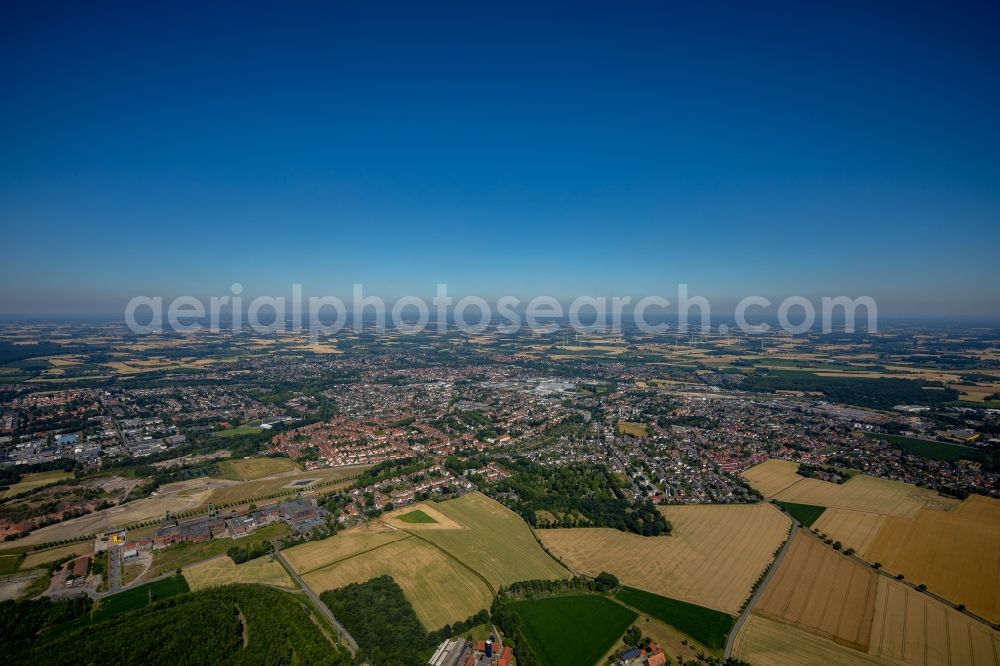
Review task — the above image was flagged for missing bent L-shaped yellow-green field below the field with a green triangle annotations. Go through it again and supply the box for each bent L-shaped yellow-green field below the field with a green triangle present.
[303,532,493,631]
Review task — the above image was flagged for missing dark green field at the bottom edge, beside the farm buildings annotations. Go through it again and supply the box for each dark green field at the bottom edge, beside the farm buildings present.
[508,594,638,666]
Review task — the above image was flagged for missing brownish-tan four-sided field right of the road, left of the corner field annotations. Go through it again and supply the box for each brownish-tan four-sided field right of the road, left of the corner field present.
[754,530,878,650]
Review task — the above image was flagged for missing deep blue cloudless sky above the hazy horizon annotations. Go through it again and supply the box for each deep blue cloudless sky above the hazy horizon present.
[0,2,1000,315]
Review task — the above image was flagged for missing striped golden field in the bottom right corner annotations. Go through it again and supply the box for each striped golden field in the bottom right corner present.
[869,576,1000,666]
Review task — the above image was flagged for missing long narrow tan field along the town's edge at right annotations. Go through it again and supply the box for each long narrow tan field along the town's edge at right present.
[743,460,958,517]
